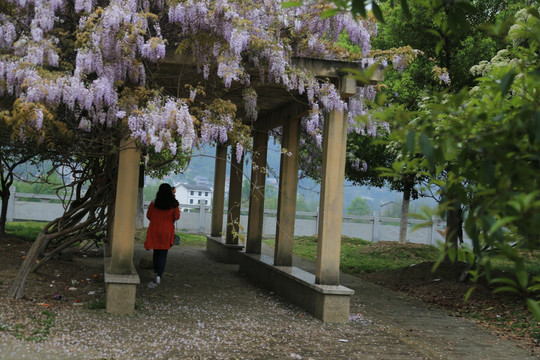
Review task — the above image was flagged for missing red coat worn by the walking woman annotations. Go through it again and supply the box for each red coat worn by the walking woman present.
[144,202,180,250]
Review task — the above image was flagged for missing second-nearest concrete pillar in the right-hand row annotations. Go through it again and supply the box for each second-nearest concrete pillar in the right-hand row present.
[274,118,300,266]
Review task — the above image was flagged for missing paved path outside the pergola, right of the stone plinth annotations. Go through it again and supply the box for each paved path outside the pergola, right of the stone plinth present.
[284,248,538,360]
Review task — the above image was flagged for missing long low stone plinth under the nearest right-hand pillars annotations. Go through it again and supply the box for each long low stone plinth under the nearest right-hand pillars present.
[239,253,354,323]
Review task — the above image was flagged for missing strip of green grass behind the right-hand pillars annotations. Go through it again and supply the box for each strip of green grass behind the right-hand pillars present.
[263,236,440,274]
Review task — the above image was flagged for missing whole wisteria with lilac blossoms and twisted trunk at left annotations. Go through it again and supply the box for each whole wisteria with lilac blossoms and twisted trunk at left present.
[0,0,386,296]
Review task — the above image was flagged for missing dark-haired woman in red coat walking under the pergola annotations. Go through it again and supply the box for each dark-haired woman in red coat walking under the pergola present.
[144,184,180,287]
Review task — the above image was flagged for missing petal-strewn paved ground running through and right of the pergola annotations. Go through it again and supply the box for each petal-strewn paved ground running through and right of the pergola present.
[0,245,536,360]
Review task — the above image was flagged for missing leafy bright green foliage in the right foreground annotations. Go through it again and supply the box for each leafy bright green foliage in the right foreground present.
[382,7,540,320]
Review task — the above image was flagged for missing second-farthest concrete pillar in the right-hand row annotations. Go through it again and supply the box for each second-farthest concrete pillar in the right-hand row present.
[225,146,244,245]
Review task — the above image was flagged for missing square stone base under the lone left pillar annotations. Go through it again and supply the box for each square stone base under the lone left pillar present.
[105,258,140,314]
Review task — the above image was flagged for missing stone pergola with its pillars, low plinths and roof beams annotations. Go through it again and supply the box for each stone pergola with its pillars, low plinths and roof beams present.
[105,51,376,322]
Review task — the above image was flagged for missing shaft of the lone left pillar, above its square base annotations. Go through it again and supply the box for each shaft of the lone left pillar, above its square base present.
[111,139,141,274]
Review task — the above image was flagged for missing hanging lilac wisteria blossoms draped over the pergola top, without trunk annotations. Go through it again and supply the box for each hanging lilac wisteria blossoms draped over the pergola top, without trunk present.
[0,0,390,166]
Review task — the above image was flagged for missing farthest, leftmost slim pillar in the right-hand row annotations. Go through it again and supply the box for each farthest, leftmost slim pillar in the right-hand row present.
[210,144,227,237]
